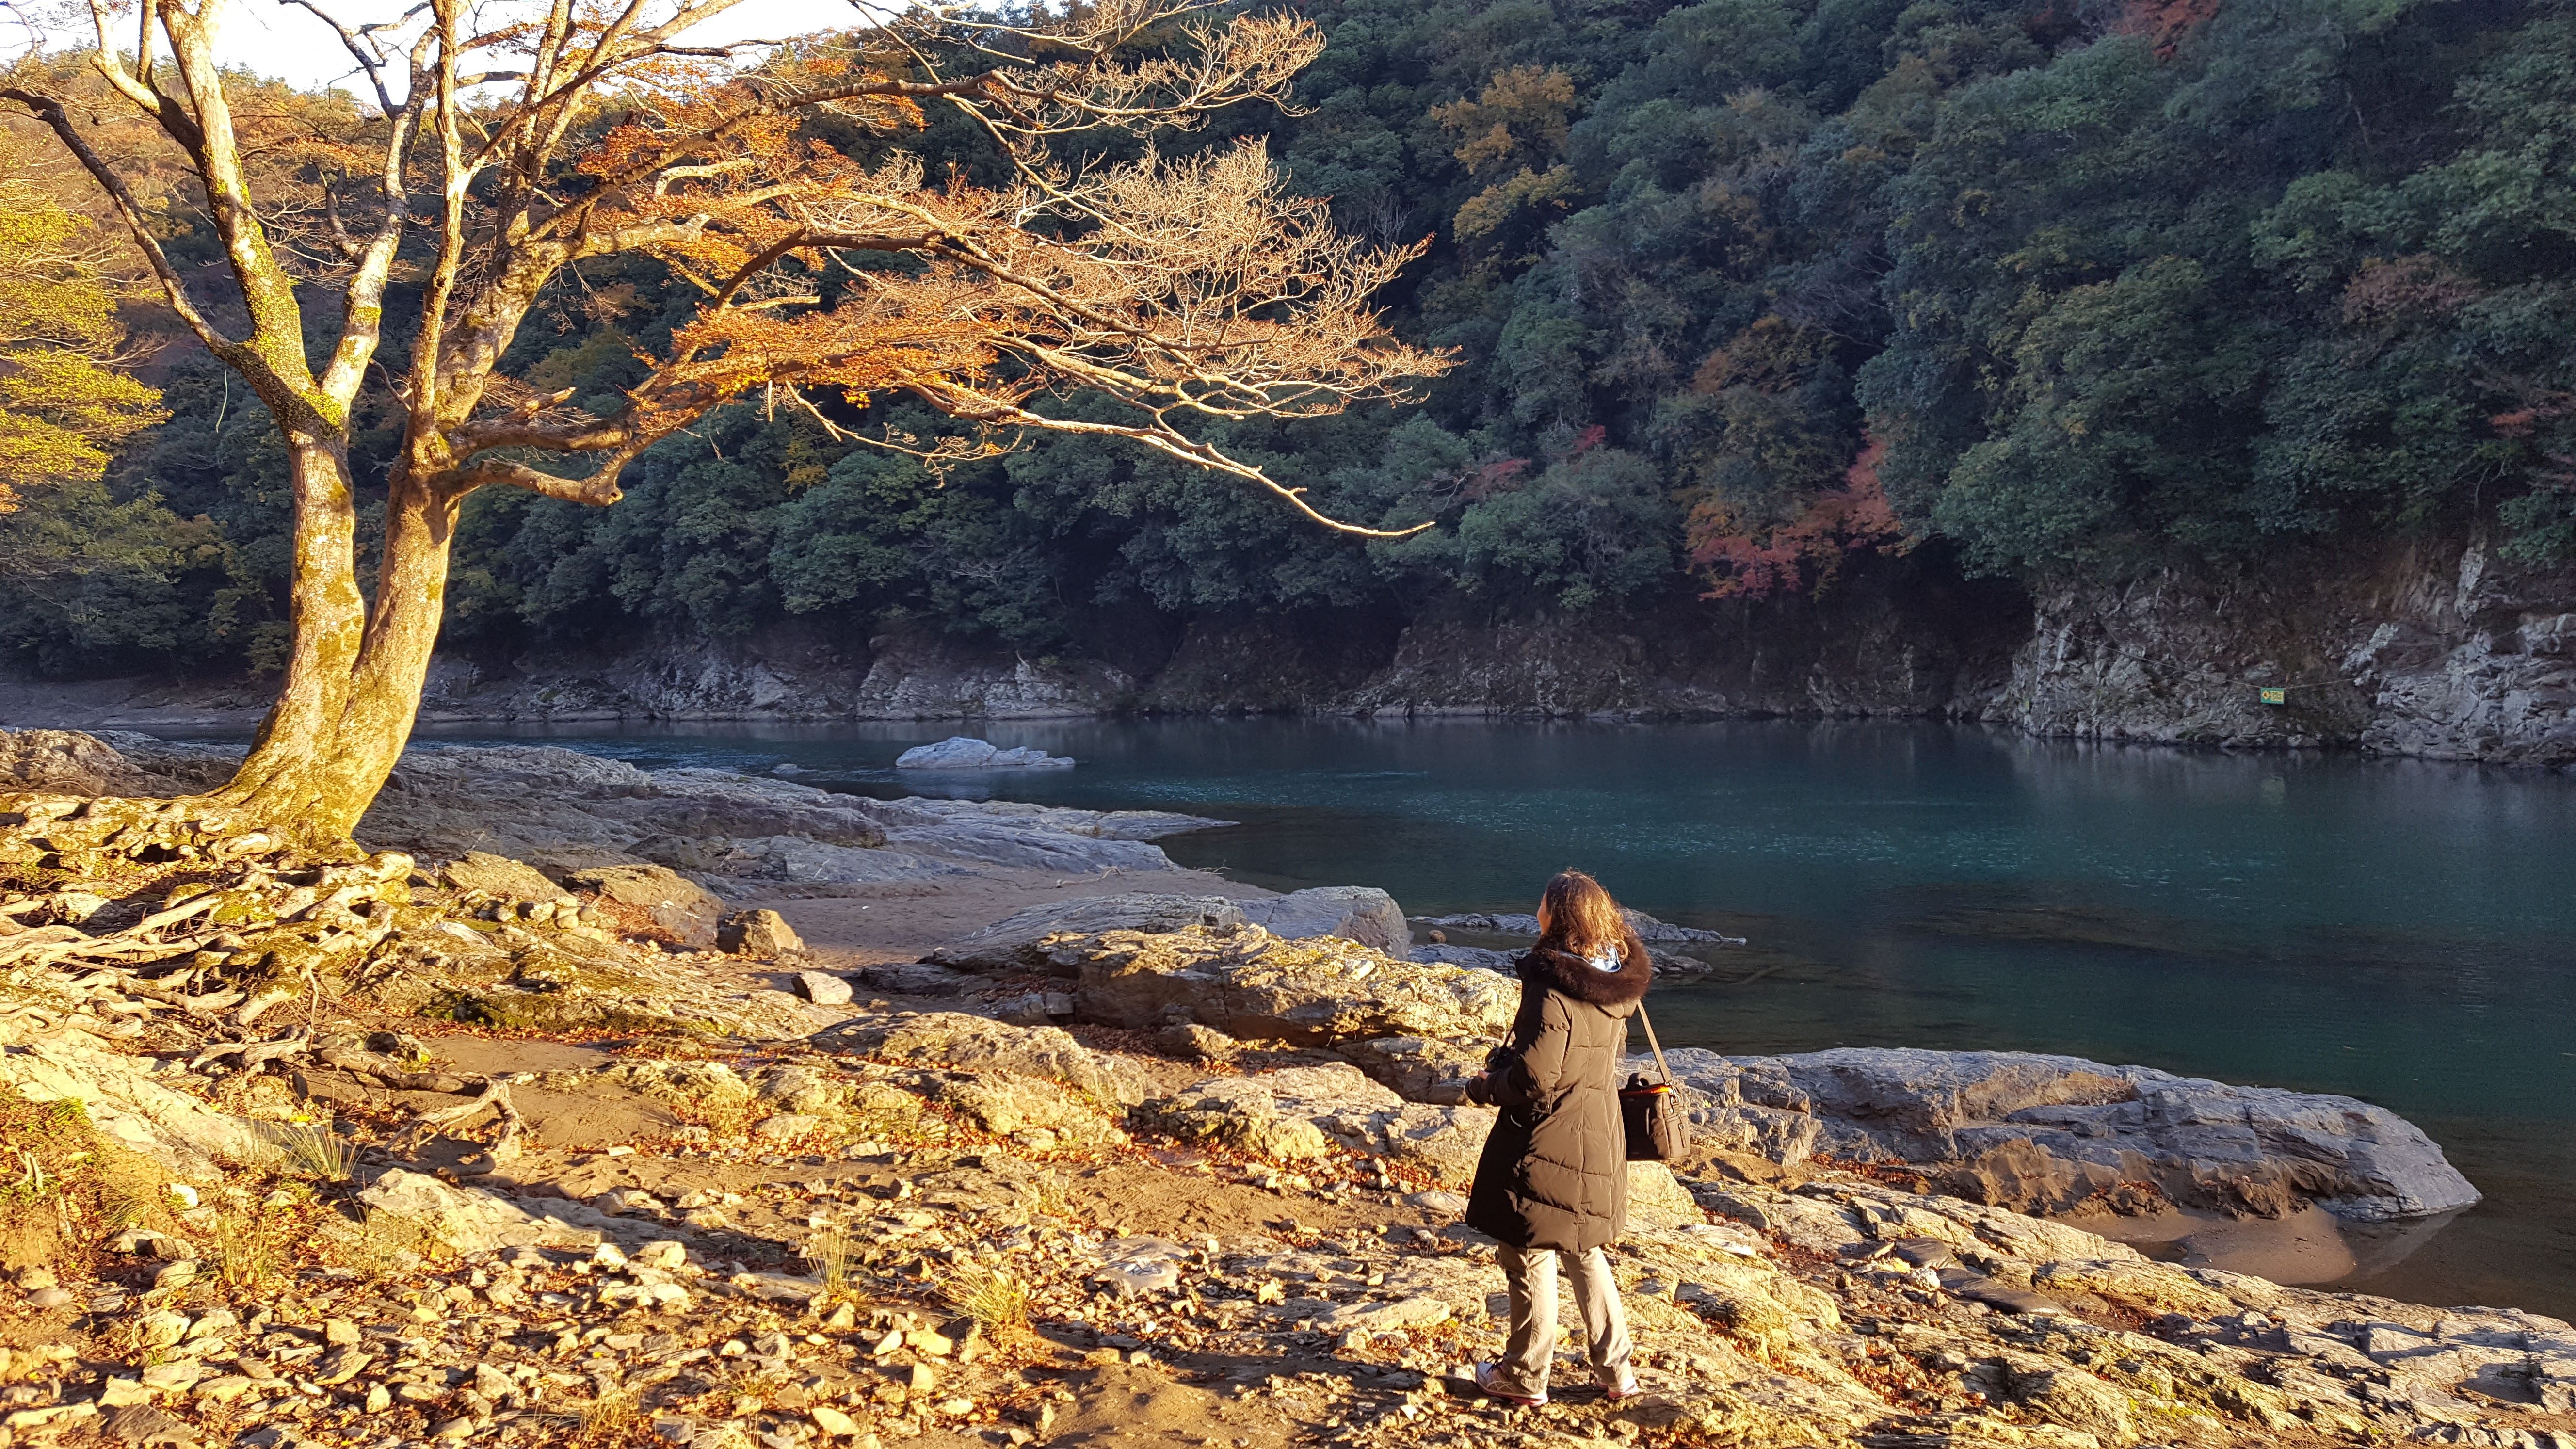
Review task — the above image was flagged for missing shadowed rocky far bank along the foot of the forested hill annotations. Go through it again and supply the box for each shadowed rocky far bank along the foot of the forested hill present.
[0,536,2576,766]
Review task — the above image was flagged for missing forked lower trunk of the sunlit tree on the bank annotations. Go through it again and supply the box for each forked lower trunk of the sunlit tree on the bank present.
[214,443,456,846]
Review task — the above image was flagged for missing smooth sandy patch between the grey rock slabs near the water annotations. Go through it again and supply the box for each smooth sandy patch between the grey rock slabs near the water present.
[732,866,1272,969]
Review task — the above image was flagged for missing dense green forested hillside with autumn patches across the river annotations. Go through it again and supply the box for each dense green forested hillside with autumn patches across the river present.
[0,0,2576,676]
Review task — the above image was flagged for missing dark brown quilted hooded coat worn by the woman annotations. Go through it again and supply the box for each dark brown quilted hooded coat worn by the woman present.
[1466,944,1654,1253]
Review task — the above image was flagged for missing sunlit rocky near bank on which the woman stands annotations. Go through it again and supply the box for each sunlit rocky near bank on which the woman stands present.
[0,735,2576,1449]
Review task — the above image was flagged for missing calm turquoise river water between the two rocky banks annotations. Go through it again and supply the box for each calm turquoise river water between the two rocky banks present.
[422,719,2576,1315]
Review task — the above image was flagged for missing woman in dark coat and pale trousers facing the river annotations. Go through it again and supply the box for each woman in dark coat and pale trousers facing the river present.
[1466,871,1654,1405]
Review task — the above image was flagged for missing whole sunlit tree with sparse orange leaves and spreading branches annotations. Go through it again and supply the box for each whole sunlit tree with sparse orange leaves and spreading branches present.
[0,0,1445,840]
